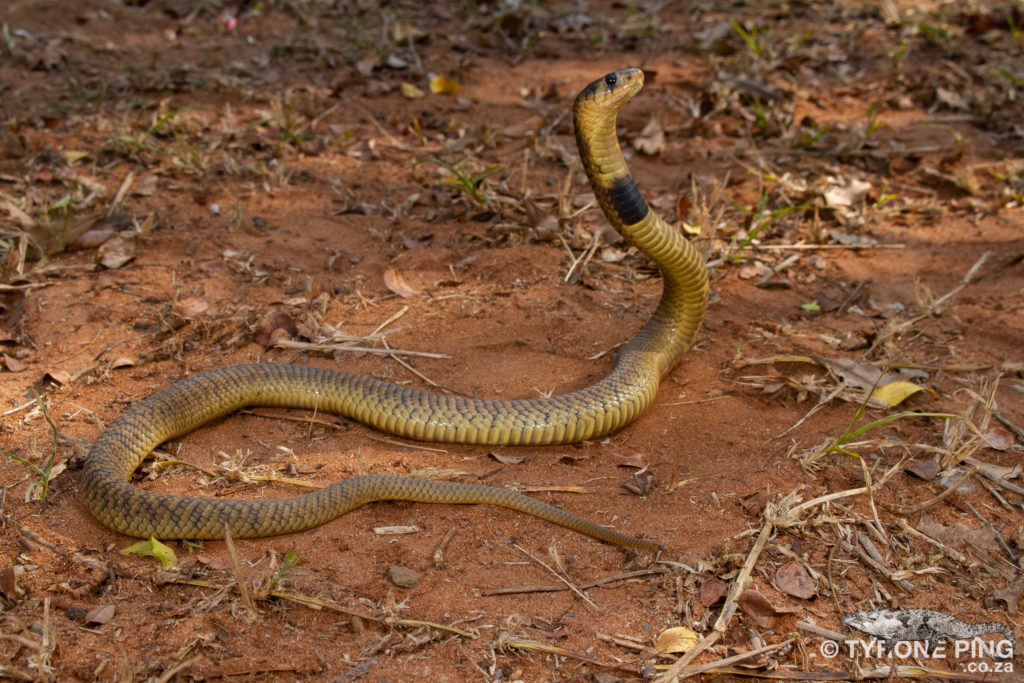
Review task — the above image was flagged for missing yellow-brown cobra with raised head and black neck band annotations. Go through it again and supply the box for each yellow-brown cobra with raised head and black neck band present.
[80,69,709,550]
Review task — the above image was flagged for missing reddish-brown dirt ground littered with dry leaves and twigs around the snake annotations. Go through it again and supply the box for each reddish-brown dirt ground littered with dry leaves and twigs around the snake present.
[0,0,1024,682]
